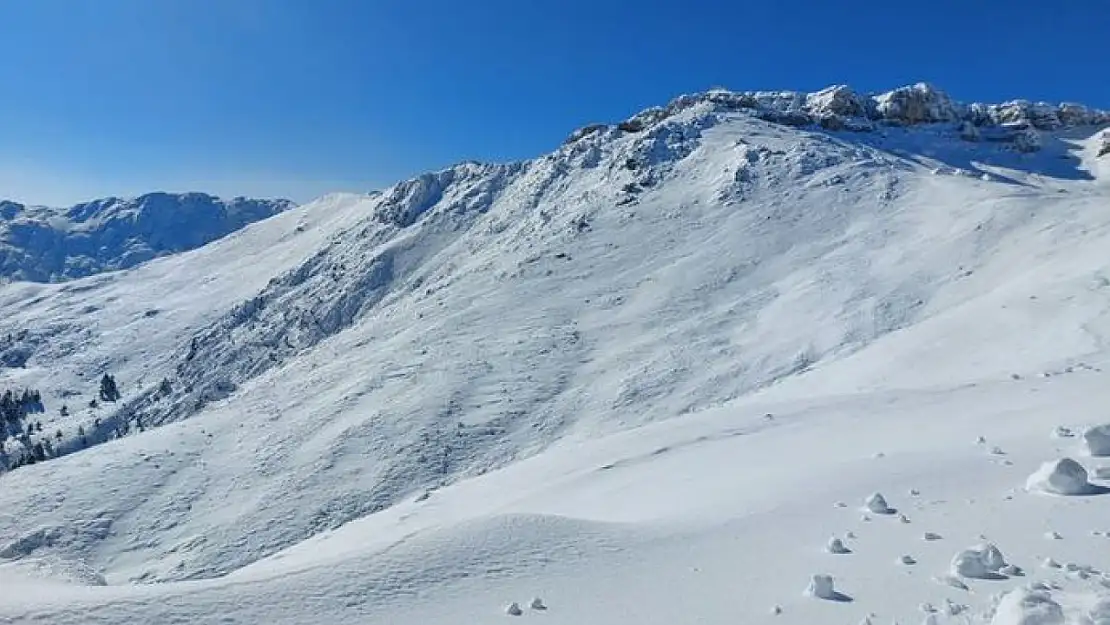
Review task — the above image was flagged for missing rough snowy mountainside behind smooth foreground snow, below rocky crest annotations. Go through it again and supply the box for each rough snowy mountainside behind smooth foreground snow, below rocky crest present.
[0,84,1110,608]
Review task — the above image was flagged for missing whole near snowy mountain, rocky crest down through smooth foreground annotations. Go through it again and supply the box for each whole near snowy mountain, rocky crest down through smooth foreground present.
[0,85,1110,625]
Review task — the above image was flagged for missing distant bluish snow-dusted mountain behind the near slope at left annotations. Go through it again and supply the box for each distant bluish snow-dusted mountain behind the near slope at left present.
[0,193,293,282]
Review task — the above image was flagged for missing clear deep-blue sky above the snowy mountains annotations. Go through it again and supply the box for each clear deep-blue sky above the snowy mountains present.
[0,0,1110,204]
